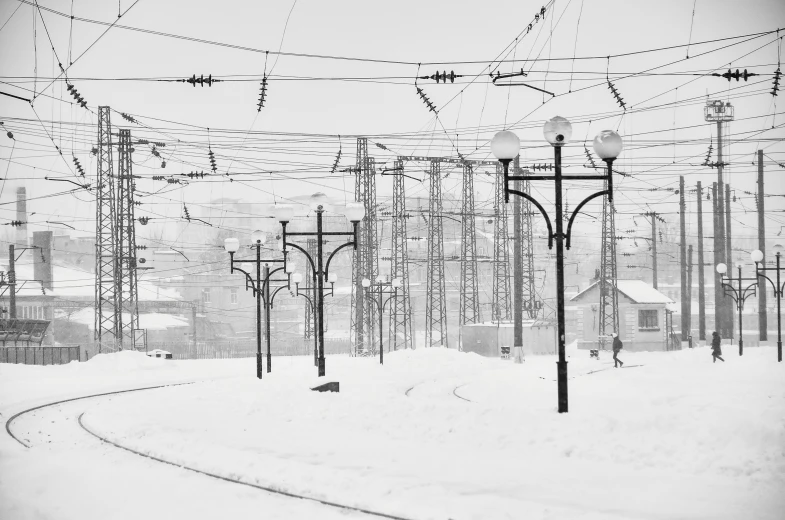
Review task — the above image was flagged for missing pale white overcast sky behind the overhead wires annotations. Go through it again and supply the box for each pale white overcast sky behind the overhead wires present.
[0,0,785,258]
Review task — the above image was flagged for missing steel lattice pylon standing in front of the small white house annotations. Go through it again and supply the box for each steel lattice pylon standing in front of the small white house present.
[598,181,619,350]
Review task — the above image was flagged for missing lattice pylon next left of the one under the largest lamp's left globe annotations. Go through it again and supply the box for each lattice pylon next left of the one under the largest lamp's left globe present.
[458,164,482,336]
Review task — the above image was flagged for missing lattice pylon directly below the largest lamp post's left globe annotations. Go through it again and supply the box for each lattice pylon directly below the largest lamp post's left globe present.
[493,165,512,322]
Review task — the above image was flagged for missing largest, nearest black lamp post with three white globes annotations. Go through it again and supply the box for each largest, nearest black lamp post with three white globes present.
[491,116,622,413]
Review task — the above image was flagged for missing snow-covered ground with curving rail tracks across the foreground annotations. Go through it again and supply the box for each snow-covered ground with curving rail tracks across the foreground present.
[0,347,785,520]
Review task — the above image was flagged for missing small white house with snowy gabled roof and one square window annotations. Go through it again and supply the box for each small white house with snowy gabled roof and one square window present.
[570,280,675,352]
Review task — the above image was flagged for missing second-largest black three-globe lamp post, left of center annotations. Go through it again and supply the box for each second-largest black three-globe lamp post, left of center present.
[275,193,365,377]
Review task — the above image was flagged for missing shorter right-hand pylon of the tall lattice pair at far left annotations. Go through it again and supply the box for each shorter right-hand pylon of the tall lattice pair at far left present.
[115,129,139,349]
